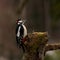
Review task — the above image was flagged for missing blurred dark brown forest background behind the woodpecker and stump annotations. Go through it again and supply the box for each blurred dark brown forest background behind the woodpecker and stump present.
[0,0,60,60]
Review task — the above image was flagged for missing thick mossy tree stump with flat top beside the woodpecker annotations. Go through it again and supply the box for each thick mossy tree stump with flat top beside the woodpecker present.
[23,32,48,60]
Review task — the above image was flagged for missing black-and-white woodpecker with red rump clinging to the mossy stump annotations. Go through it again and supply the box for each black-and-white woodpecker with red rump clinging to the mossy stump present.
[16,19,27,52]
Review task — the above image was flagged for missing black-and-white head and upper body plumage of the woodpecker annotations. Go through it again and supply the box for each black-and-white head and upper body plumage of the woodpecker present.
[17,21,27,37]
